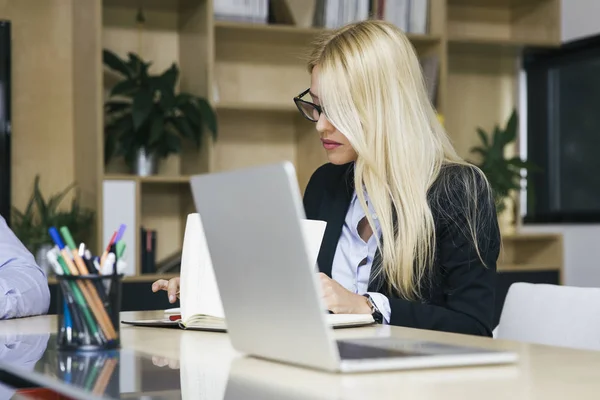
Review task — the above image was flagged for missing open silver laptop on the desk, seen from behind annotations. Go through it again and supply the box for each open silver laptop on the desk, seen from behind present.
[190,162,517,372]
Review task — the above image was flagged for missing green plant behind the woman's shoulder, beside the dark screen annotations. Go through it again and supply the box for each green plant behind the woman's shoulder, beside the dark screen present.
[471,110,537,227]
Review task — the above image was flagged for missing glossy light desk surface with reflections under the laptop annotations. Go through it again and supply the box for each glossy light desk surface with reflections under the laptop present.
[0,312,600,400]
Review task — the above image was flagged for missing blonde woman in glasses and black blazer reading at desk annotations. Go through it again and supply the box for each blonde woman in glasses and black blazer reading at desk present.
[153,21,500,336]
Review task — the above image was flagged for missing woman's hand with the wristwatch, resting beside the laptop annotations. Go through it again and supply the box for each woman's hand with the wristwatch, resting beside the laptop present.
[319,272,371,314]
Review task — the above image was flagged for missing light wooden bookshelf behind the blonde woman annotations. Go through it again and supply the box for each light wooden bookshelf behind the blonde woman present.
[99,0,561,281]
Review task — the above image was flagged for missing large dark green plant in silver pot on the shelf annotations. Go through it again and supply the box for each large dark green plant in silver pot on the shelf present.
[103,50,217,175]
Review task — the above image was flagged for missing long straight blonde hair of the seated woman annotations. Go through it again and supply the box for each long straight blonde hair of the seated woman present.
[308,21,487,300]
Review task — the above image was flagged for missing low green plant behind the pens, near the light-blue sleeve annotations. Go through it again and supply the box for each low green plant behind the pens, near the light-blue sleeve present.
[11,175,95,273]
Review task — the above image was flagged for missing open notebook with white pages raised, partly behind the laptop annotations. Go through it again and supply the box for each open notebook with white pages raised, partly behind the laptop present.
[122,213,374,332]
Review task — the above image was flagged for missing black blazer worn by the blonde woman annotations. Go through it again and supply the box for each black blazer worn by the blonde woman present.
[304,163,500,336]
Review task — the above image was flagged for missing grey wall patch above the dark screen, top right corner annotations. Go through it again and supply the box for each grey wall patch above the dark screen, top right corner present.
[561,0,600,42]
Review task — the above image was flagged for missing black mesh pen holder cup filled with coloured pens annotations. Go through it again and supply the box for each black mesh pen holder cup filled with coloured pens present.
[56,274,123,351]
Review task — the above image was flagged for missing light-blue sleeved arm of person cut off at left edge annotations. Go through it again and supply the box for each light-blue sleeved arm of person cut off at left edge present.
[0,217,50,319]
